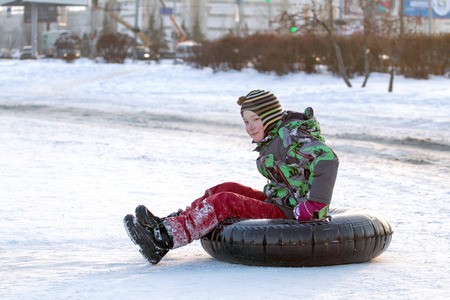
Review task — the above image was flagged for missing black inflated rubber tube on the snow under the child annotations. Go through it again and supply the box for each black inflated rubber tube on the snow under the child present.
[201,208,393,267]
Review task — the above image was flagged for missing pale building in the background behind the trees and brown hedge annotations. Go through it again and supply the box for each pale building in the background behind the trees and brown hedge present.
[0,0,450,53]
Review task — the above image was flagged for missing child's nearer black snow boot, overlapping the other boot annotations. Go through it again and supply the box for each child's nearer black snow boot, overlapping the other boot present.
[123,215,173,265]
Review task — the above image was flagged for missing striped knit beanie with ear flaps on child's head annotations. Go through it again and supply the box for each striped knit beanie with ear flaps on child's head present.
[237,90,282,134]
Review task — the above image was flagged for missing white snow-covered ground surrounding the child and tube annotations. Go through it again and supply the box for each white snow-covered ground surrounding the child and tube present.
[0,60,450,299]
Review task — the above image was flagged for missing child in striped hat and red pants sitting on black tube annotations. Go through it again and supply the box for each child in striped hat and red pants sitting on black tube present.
[124,90,339,264]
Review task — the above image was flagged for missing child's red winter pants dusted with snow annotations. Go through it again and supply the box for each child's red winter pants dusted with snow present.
[165,182,286,249]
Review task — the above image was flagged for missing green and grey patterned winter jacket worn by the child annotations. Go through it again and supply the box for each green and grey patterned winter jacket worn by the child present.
[255,111,339,218]
